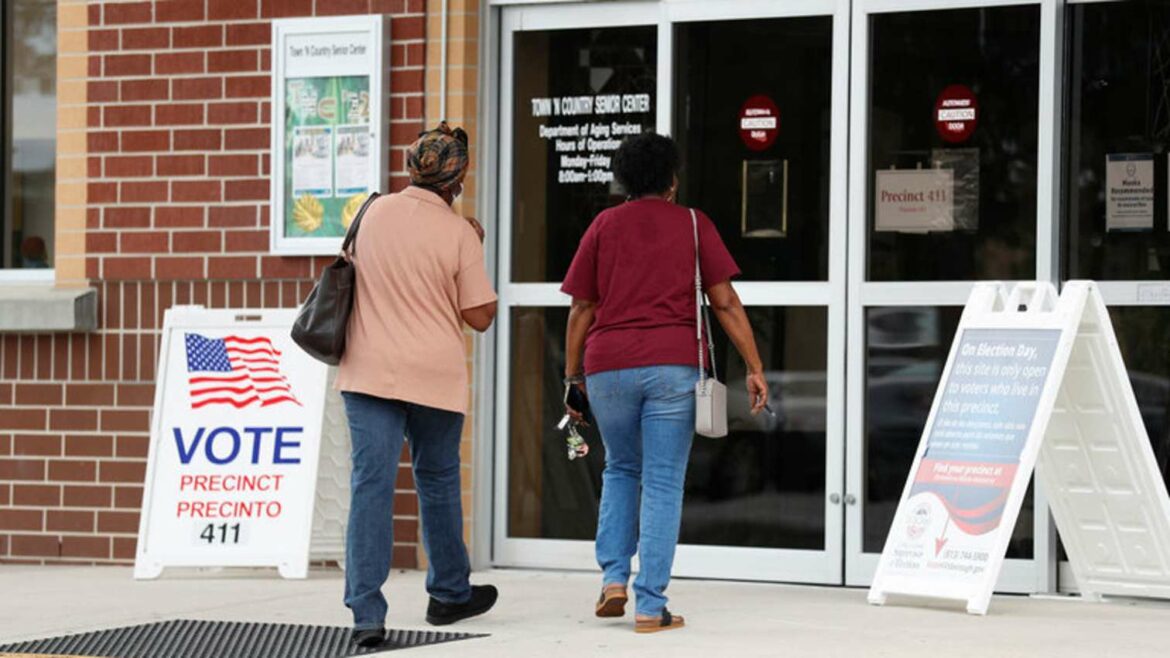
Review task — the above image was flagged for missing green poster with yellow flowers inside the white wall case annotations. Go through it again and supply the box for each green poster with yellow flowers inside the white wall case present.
[284,76,371,238]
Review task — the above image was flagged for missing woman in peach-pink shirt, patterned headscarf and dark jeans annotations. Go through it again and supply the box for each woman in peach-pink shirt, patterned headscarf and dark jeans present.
[337,123,497,646]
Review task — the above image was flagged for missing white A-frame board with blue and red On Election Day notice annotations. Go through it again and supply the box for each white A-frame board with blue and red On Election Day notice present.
[869,281,1170,615]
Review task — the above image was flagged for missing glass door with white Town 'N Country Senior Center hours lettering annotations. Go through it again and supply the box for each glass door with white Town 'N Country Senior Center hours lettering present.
[493,2,667,569]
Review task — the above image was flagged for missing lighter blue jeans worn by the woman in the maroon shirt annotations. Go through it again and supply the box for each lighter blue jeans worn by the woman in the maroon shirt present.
[586,365,698,616]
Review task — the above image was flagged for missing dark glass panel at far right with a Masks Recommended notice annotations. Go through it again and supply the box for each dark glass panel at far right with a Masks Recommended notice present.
[1060,2,1170,589]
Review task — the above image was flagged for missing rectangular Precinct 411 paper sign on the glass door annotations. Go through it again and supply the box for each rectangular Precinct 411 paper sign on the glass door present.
[874,169,955,233]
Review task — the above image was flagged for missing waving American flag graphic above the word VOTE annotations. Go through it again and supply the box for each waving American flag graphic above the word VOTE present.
[187,334,301,409]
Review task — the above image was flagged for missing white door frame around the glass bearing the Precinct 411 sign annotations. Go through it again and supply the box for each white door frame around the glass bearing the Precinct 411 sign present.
[845,0,1064,592]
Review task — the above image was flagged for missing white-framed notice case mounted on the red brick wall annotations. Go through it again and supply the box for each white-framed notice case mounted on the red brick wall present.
[271,16,390,255]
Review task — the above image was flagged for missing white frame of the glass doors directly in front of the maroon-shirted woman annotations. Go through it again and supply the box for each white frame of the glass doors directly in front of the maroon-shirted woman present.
[481,0,849,584]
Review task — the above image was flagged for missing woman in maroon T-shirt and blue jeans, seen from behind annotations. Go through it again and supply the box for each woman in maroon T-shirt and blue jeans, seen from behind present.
[562,133,768,632]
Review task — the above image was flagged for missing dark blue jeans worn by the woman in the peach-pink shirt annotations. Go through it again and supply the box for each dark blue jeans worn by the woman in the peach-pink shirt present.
[342,392,472,630]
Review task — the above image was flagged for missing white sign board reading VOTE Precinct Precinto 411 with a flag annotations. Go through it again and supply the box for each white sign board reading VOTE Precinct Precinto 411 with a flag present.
[135,307,326,578]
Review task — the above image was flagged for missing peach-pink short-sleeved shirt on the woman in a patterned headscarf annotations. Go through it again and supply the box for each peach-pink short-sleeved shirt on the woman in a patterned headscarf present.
[336,187,496,413]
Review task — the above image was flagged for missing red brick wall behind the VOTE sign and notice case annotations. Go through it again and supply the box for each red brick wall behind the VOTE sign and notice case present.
[0,0,426,567]
